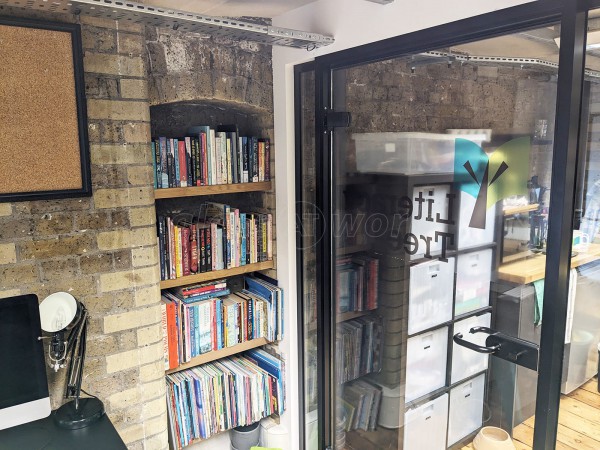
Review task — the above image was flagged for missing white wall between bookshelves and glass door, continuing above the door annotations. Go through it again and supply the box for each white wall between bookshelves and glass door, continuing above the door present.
[273,0,530,450]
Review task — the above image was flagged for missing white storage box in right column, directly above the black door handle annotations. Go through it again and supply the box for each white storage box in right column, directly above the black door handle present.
[454,249,493,316]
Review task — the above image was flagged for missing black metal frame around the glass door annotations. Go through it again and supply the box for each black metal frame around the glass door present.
[296,0,600,450]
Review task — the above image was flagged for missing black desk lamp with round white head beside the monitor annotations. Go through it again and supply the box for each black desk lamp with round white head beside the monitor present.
[40,292,104,429]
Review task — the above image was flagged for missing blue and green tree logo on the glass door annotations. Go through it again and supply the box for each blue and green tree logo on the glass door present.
[454,137,531,229]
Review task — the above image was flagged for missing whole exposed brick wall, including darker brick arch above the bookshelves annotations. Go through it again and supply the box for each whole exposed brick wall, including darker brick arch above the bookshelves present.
[0,7,276,450]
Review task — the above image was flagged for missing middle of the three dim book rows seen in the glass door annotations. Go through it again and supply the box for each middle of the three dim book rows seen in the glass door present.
[335,316,383,383]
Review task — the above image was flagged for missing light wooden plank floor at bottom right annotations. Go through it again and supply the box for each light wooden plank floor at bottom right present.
[463,378,600,450]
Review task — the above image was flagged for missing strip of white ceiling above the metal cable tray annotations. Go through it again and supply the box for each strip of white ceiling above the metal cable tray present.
[138,0,315,18]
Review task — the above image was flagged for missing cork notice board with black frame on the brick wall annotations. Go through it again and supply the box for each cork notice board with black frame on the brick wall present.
[0,18,91,201]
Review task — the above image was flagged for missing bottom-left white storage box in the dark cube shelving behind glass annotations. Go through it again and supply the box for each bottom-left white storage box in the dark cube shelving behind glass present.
[403,394,448,450]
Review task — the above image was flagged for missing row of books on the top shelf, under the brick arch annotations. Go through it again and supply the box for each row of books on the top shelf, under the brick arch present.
[152,126,271,189]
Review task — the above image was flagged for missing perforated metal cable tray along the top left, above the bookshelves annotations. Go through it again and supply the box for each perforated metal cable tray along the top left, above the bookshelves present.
[0,0,334,50]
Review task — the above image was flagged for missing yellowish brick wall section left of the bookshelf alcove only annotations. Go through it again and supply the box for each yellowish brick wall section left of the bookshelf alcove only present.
[0,10,167,449]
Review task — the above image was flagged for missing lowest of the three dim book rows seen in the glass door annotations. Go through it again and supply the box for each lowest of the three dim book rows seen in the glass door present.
[342,380,382,431]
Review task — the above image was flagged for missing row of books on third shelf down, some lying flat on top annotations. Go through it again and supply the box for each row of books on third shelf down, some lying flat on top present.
[161,277,284,370]
